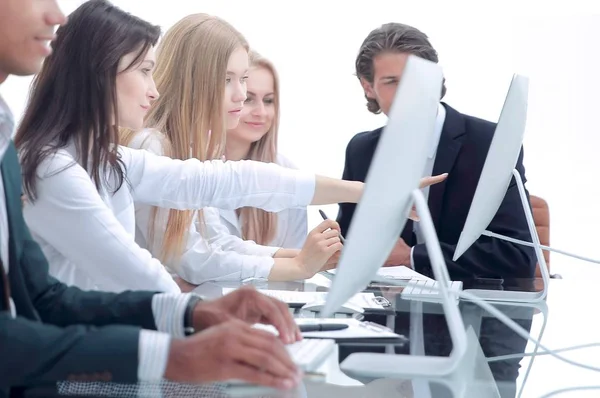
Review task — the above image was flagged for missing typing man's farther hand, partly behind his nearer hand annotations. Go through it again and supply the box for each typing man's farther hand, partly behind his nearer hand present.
[193,286,302,344]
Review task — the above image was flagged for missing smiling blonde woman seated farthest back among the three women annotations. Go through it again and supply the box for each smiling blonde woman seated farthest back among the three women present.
[219,51,307,249]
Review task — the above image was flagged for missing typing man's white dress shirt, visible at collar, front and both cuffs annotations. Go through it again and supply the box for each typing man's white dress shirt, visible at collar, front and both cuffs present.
[0,92,191,380]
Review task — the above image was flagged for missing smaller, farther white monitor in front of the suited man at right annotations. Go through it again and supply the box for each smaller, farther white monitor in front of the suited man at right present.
[453,75,549,301]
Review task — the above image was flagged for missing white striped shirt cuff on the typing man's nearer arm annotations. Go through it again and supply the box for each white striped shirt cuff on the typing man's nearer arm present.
[138,330,171,381]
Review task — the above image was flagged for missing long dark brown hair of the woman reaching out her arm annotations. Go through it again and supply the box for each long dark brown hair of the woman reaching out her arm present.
[15,0,160,201]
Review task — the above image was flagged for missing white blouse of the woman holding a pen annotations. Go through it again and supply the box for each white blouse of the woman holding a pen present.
[129,130,306,284]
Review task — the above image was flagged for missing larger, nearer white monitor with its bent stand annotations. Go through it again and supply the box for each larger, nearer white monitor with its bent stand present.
[321,56,476,379]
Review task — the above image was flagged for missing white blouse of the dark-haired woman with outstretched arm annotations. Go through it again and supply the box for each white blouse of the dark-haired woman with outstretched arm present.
[23,140,315,292]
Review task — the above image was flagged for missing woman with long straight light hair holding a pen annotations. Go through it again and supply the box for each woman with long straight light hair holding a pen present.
[123,14,339,284]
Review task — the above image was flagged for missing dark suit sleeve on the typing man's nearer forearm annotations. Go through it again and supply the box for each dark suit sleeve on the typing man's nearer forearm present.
[0,312,139,388]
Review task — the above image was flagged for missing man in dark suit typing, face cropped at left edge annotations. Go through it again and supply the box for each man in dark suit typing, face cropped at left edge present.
[0,0,300,397]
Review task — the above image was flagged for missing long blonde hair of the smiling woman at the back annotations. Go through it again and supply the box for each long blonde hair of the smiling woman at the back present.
[238,51,279,245]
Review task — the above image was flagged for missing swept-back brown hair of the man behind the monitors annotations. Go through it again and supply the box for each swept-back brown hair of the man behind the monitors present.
[355,22,446,114]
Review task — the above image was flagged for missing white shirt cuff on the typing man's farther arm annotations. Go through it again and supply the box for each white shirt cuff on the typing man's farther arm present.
[152,293,192,337]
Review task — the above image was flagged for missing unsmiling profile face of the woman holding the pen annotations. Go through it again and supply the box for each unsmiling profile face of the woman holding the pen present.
[223,47,249,130]
